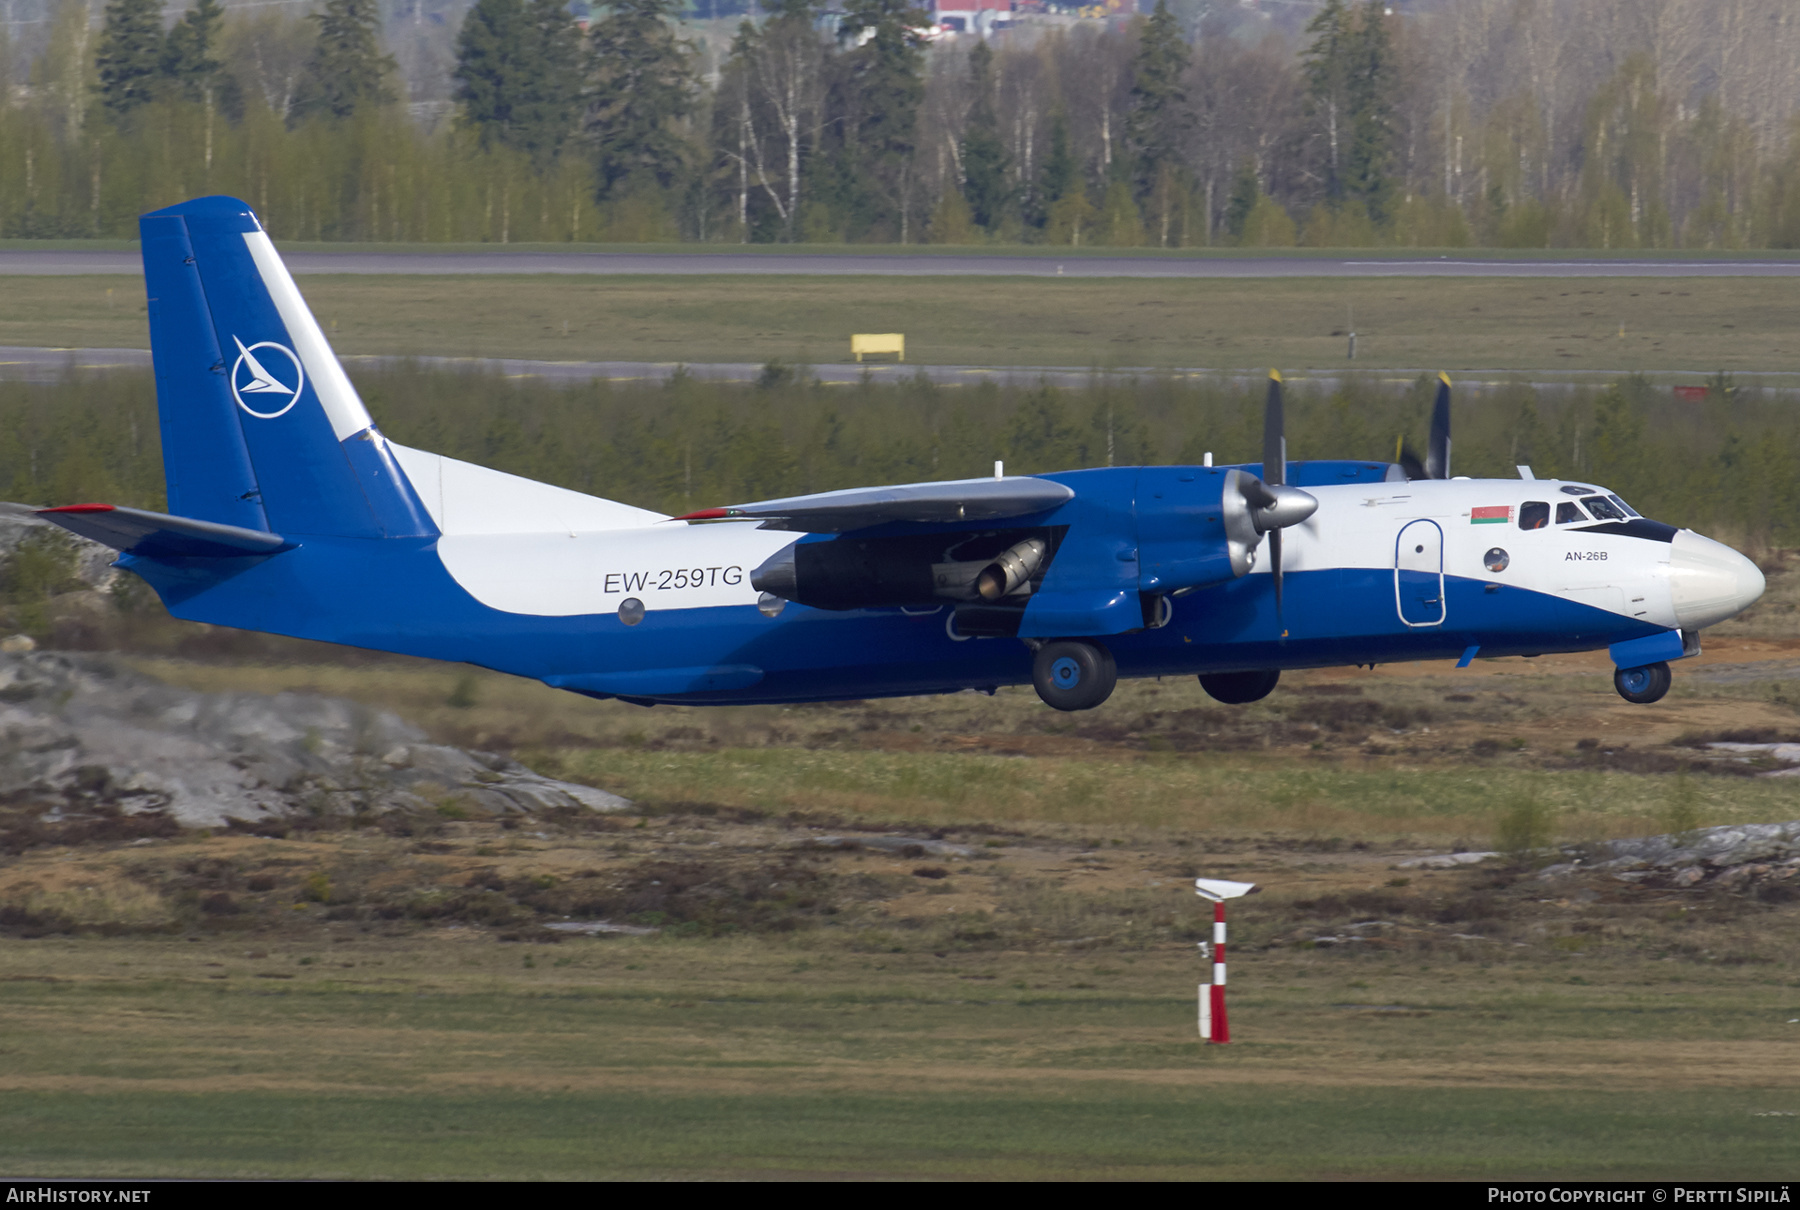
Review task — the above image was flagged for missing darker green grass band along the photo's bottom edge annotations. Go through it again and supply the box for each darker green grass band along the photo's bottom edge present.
[0,1075,1795,1181]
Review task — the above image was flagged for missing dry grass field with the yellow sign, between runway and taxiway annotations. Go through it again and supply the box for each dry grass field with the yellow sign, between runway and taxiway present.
[0,275,1800,375]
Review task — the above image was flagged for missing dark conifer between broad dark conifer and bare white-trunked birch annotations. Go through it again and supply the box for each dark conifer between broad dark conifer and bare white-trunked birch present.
[587,0,697,196]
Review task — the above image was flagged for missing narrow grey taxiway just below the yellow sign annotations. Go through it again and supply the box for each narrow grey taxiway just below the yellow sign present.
[0,346,1800,389]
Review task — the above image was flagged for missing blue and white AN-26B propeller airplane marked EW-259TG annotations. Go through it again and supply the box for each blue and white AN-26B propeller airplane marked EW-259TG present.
[40,196,1764,711]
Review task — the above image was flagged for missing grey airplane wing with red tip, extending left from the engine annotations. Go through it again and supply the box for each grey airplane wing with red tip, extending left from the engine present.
[671,475,1075,533]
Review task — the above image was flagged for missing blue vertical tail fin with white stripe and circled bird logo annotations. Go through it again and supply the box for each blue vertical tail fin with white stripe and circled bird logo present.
[139,198,437,538]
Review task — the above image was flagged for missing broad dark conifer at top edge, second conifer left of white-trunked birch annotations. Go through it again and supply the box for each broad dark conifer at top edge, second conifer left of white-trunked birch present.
[454,0,581,164]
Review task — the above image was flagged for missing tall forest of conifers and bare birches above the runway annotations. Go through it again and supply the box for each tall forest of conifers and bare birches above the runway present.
[0,0,1800,248]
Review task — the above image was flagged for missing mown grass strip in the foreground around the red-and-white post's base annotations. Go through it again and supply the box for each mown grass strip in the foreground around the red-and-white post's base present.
[0,938,1800,1179]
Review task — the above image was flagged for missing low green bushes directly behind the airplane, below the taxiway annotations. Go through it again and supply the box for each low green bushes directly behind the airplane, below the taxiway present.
[0,366,1800,549]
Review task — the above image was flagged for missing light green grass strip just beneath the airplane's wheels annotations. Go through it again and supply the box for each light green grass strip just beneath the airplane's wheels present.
[547,749,1795,844]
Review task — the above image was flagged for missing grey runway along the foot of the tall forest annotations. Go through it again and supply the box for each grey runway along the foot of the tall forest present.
[0,248,1800,277]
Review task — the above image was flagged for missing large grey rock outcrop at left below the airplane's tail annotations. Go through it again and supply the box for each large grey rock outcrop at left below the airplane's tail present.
[0,652,628,848]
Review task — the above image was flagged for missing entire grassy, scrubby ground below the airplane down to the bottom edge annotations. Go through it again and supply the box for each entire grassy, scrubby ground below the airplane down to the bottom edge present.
[0,630,1800,1179]
